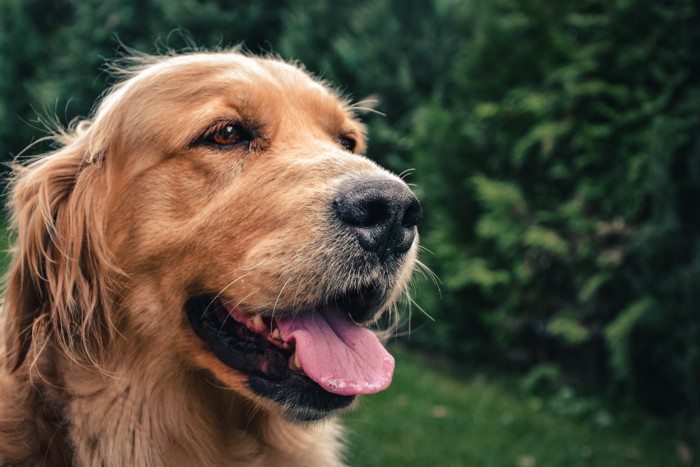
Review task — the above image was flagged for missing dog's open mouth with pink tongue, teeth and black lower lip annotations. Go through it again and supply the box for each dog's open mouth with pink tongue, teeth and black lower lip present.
[186,290,394,421]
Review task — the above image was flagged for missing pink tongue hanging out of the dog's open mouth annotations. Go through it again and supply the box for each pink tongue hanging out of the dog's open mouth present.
[277,309,394,396]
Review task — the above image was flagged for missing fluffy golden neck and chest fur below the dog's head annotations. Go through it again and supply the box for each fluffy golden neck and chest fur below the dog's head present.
[0,326,348,466]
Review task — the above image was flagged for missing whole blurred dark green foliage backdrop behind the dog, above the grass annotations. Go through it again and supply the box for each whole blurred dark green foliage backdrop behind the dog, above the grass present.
[0,0,700,462]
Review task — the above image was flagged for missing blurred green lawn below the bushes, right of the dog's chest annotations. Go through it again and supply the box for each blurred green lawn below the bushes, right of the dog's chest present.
[345,347,680,467]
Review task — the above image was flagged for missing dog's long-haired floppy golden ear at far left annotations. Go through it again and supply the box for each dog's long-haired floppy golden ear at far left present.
[4,127,116,370]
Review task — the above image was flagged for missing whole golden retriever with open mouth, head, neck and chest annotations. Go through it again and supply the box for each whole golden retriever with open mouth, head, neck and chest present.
[0,50,422,466]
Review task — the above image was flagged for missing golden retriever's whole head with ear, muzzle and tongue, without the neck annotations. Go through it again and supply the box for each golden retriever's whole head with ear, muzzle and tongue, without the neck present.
[6,53,421,421]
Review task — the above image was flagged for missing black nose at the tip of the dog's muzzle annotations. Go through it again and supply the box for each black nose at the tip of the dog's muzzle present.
[333,179,423,260]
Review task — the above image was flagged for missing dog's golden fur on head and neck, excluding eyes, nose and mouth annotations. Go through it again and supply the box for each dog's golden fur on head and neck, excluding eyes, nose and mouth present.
[0,52,417,466]
